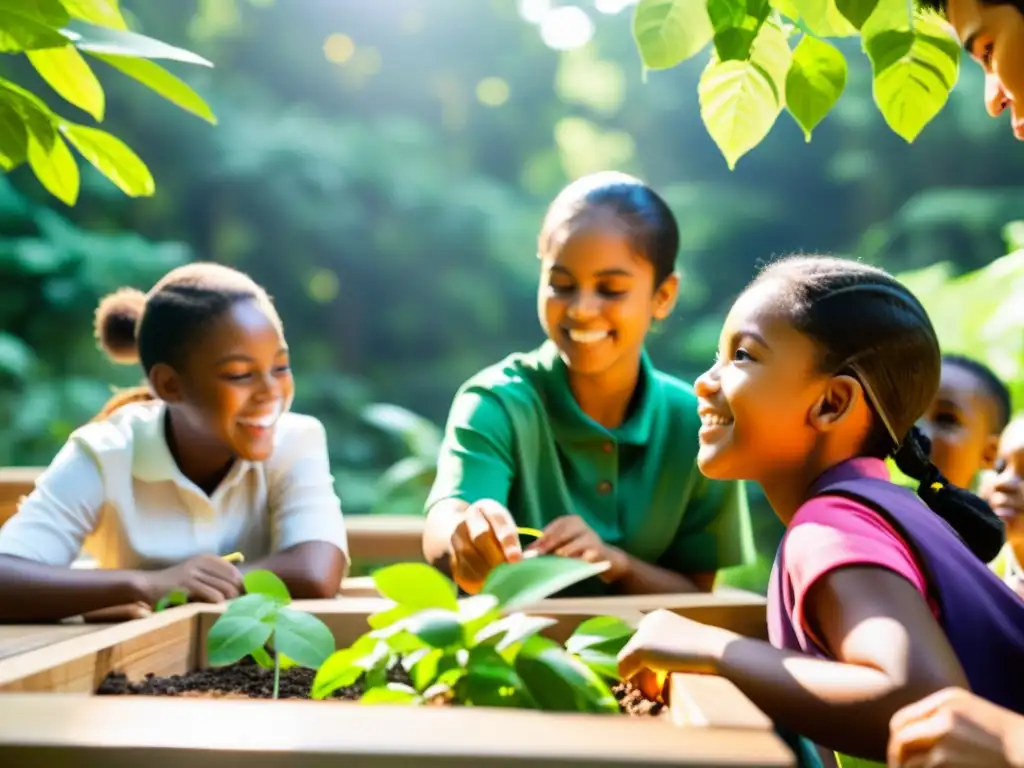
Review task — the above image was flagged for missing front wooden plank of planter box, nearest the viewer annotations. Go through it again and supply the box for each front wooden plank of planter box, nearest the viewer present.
[0,694,794,768]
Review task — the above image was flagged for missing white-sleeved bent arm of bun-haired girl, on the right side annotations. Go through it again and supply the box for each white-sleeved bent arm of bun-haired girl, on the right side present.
[262,416,349,600]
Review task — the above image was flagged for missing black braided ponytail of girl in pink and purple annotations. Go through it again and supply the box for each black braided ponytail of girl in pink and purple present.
[893,427,1006,562]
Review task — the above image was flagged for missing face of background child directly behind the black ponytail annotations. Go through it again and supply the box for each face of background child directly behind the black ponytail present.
[918,362,998,488]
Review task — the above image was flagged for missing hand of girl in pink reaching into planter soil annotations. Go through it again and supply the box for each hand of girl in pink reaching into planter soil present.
[618,610,735,687]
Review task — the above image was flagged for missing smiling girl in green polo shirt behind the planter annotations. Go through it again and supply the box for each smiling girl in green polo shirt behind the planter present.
[423,172,753,594]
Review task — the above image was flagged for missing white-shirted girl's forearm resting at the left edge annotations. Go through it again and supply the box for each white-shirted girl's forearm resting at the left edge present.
[0,555,151,623]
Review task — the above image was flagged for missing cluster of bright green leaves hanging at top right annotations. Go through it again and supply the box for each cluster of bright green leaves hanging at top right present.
[633,0,961,168]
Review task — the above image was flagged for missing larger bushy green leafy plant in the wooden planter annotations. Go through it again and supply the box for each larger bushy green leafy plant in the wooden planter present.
[311,556,633,713]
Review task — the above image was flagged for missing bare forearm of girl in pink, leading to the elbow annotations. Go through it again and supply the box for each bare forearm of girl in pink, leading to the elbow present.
[718,636,943,762]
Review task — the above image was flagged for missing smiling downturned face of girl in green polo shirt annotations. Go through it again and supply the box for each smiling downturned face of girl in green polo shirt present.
[538,218,678,376]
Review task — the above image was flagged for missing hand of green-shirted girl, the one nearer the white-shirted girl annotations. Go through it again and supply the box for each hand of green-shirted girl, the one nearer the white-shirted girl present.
[451,499,522,595]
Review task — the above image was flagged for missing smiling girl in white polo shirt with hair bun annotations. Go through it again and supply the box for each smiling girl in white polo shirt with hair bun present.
[0,263,348,622]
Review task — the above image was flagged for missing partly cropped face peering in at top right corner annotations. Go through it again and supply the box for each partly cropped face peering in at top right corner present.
[946,0,1024,139]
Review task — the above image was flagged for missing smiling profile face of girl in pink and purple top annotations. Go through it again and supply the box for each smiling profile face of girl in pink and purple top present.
[695,282,826,481]
